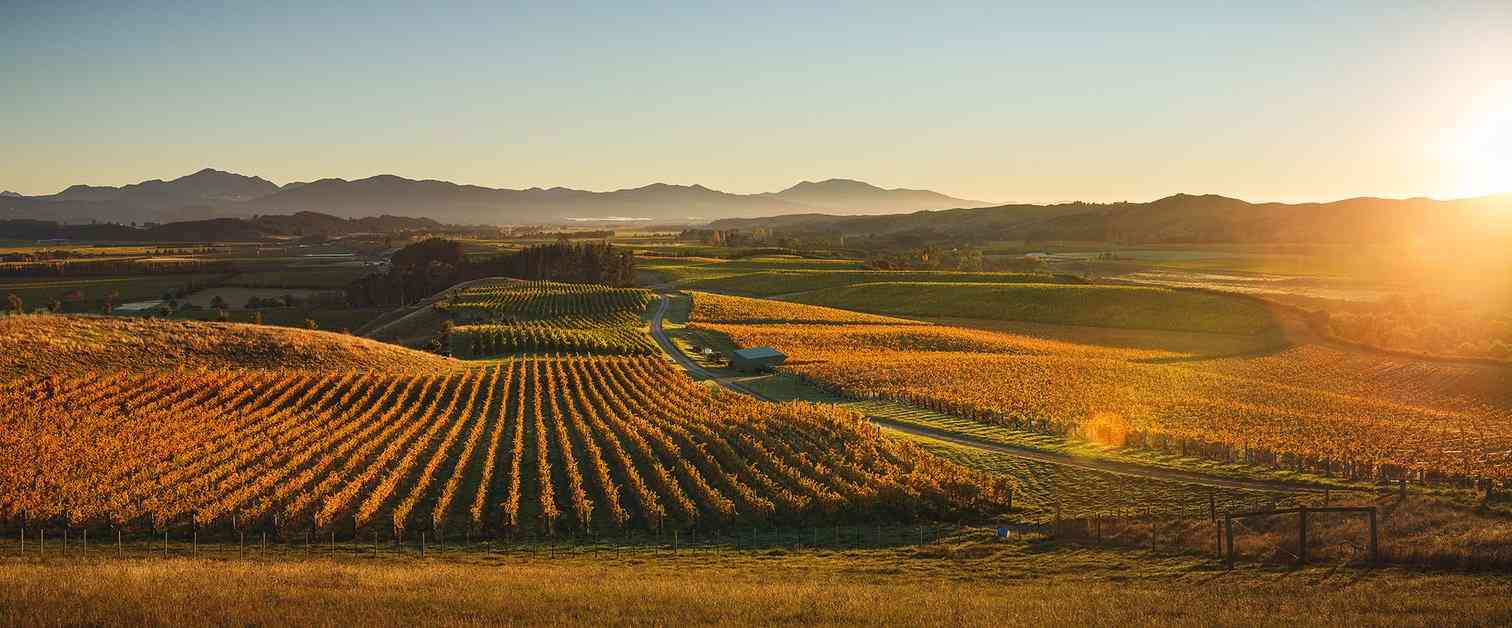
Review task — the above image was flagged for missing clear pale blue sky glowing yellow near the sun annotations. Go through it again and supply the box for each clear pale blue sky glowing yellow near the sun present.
[0,0,1512,203]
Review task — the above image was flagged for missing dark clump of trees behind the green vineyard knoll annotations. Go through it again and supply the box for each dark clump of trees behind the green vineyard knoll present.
[346,238,635,307]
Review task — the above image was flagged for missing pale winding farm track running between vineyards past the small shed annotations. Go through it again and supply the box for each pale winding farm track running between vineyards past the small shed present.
[650,292,1325,493]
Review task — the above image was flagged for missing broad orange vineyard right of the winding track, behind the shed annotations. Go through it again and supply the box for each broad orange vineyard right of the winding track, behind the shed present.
[694,288,1512,481]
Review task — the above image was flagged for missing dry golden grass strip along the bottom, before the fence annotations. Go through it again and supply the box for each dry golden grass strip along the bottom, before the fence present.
[0,540,1512,626]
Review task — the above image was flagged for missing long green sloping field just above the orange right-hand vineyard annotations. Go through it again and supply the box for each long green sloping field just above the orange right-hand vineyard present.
[789,281,1275,334]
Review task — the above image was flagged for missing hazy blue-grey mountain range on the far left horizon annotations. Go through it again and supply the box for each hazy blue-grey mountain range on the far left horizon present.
[0,168,990,224]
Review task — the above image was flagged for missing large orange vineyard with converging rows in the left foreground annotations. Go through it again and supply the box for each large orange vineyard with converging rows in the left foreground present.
[0,357,1009,537]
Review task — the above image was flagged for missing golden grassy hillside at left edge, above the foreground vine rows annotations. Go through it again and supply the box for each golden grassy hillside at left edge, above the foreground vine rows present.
[0,315,455,377]
